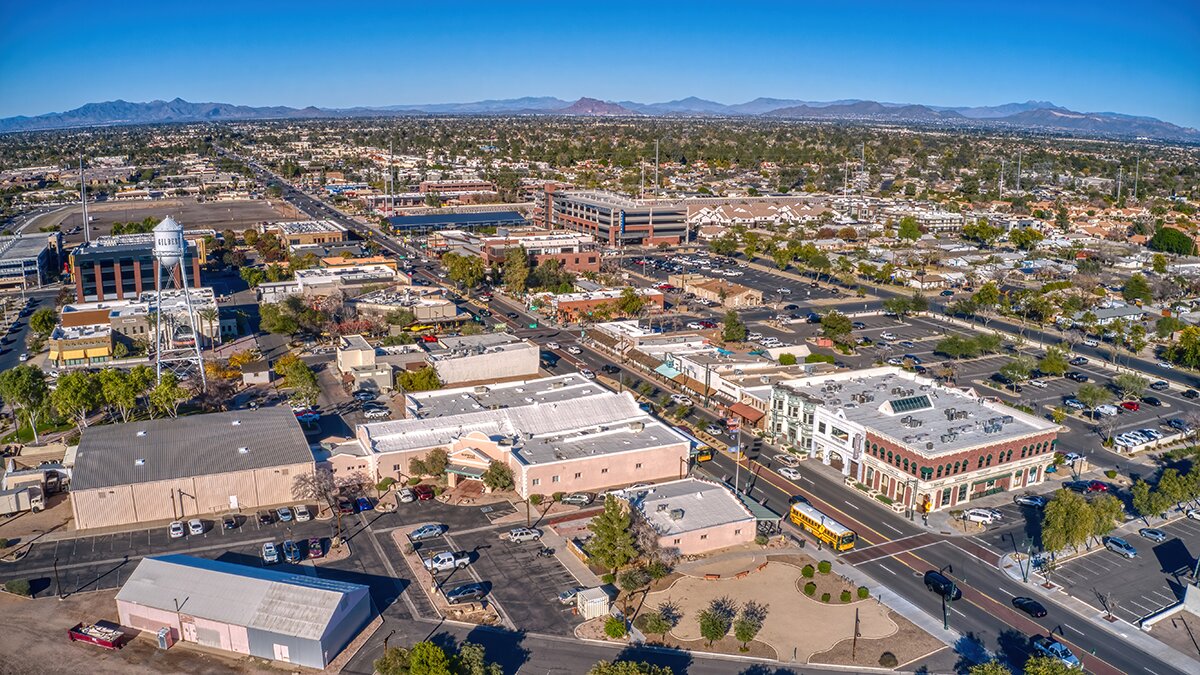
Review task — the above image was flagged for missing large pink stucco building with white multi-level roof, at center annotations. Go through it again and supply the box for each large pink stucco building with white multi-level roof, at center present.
[338,375,691,497]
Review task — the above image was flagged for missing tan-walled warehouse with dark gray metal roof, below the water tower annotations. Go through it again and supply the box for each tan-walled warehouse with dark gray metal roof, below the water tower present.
[71,407,314,530]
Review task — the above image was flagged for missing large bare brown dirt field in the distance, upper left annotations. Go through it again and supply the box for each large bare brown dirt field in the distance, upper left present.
[54,197,301,244]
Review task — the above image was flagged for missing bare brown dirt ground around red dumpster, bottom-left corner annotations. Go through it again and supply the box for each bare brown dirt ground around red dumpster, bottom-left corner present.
[0,590,288,675]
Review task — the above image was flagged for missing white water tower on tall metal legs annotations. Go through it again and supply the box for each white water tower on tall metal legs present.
[154,216,205,390]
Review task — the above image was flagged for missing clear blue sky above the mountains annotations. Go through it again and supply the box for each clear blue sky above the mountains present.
[0,0,1200,127]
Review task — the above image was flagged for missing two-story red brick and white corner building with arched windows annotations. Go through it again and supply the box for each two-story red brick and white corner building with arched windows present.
[768,368,1060,510]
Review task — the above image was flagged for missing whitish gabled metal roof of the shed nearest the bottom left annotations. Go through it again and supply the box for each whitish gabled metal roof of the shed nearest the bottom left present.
[116,555,367,640]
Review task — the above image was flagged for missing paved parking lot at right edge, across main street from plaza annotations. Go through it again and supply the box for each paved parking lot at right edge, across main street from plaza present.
[1051,518,1200,622]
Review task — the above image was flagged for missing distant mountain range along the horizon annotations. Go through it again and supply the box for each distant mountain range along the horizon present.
[0,96,1200,143]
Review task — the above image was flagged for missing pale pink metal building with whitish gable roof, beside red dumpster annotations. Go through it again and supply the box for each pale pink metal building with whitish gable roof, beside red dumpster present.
[116,555,374,670]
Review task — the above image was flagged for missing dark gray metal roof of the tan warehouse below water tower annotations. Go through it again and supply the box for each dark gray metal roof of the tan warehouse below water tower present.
[71,407,313,490]
